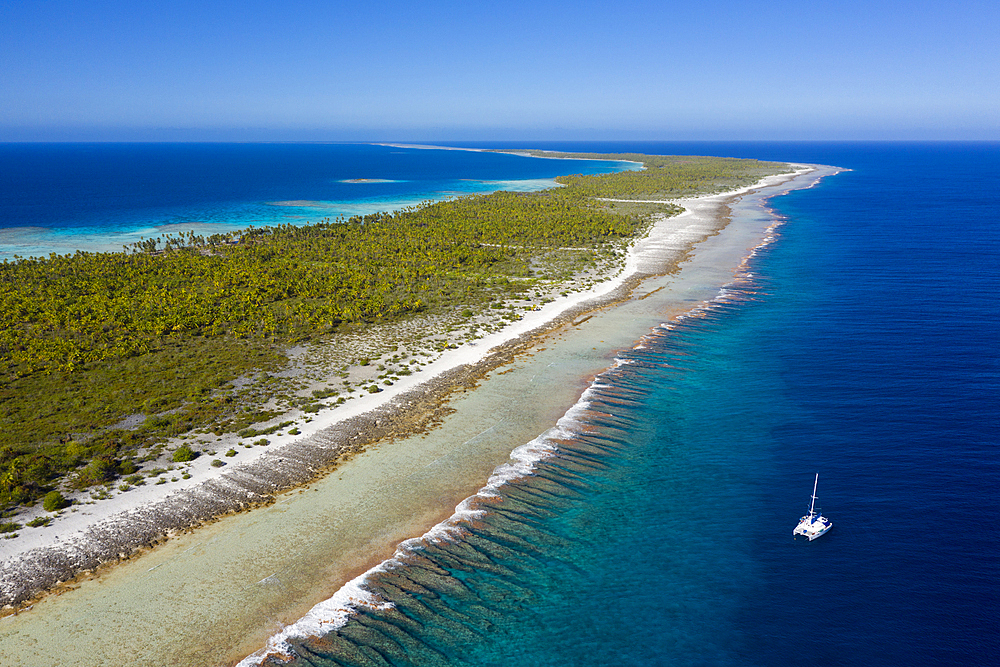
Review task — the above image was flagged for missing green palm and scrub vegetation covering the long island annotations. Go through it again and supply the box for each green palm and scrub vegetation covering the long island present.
[0,155,787,509]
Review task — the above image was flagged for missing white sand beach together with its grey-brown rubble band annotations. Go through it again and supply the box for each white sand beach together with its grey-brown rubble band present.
[0,165,828,667]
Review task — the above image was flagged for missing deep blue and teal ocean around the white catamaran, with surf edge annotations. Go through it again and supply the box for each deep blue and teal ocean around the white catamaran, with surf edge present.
[240,144,1000,666]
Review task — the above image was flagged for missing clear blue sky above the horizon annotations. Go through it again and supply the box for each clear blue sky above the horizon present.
[0,0,1000,141]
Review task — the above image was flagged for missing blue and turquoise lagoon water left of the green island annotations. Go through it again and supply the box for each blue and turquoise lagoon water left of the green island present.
[0,143,636,259]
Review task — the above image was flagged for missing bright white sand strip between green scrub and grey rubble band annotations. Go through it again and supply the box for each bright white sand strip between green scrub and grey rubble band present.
[0,165,811,596]
